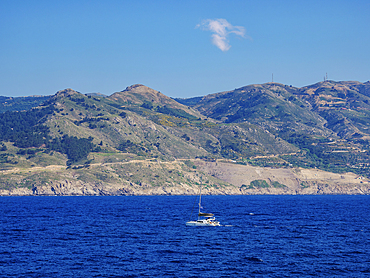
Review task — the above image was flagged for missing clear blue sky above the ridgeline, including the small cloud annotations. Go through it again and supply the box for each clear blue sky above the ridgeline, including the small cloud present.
[0,0,370,98]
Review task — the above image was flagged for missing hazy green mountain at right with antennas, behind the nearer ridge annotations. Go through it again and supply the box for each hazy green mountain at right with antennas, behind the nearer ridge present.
[178,81,370,173]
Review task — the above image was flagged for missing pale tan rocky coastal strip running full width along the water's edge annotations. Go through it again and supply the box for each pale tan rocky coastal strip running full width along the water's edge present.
[0,159,370,196]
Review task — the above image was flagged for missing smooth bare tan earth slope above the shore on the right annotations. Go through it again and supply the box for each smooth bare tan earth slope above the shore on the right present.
[196,161,370,194]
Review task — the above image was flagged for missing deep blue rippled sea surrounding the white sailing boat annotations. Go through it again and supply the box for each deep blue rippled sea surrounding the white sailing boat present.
[0,195,370,278]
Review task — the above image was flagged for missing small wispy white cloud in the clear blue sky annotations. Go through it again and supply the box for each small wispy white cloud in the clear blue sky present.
[196,18,245,51]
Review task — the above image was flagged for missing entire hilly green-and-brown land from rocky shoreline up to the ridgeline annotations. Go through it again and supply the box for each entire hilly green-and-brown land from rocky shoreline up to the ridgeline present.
[0,81,370,195]
